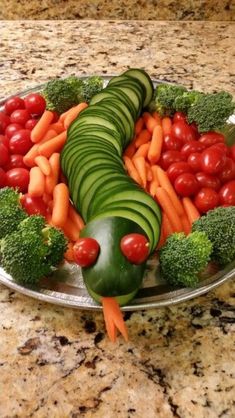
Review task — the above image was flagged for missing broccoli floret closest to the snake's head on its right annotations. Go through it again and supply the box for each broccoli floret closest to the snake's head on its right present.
[160,232,212,287]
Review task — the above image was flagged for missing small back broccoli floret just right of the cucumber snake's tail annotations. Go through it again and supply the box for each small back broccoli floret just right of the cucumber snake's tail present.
[154,84,187,116]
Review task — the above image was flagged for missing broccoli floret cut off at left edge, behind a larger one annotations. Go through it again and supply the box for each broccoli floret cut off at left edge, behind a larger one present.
[0,187,28,239]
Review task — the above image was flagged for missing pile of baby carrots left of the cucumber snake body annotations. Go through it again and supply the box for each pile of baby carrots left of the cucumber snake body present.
[23,103,88,261]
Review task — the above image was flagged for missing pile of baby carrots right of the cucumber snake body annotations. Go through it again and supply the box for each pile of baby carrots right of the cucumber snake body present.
[123,112,200,248]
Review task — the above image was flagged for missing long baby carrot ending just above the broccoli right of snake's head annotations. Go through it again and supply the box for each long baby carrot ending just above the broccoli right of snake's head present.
[156,187,183,232]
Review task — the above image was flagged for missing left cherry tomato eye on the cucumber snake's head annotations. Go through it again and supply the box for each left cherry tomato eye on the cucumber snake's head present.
[73,237,100,267]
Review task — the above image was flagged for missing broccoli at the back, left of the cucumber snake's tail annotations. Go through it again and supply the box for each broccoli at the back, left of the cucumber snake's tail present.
[42,76,103,114]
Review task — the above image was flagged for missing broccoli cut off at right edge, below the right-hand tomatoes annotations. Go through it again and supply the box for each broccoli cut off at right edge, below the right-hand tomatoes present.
[192,206,235,266]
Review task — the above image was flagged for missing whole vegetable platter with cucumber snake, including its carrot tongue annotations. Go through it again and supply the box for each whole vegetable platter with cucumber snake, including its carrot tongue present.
[0,69,235,341]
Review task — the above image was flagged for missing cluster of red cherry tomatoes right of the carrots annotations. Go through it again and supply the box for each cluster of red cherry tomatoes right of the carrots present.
[159,112,235,213]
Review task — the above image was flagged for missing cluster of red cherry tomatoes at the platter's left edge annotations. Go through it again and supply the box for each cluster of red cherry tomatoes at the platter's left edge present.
[0,93,46,193]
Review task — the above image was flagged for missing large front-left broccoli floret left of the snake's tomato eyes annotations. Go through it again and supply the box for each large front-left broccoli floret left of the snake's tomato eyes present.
[0,215,67,285]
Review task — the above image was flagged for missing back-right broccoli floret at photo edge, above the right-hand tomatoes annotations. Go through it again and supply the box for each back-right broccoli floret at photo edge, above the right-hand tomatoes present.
[187,91,235,132]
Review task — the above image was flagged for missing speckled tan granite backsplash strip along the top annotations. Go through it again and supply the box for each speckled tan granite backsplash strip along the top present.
[0,0,235,21]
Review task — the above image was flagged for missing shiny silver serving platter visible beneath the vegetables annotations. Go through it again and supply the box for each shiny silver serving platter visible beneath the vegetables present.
[0,76,235,311]
